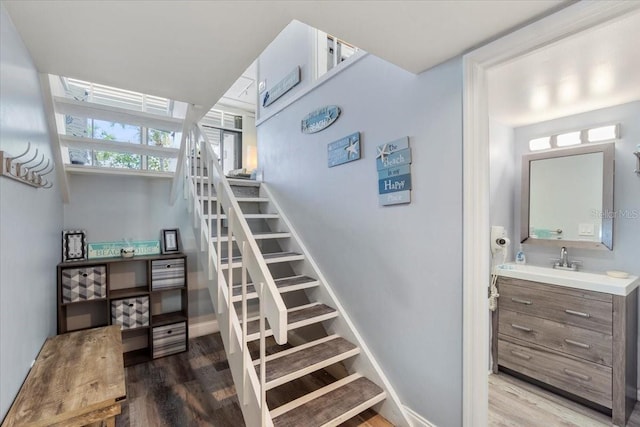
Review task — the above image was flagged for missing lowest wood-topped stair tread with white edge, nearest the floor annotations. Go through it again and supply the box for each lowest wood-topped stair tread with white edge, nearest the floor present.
[272,377,386,427]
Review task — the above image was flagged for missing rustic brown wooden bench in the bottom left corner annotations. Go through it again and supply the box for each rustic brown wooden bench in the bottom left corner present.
[2,325,126,427]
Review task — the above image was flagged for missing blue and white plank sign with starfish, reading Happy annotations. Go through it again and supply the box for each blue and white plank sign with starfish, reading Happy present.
[376,136,411,206]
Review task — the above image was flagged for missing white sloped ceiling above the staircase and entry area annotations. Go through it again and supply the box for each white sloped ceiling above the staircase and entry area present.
[2,0,571,111]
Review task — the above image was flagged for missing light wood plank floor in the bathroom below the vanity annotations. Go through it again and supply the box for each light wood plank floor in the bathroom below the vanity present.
[489,373,640,427]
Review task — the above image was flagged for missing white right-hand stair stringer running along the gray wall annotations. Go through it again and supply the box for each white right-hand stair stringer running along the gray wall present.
[260,182,412,426]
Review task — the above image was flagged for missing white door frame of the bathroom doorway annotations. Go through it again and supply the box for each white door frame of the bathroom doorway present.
[462,1,640,427]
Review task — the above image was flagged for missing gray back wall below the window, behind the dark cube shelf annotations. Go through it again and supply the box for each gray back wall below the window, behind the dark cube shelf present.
[64,175,215,325]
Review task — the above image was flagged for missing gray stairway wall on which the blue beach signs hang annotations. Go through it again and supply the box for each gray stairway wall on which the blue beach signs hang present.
[258,25,462,426]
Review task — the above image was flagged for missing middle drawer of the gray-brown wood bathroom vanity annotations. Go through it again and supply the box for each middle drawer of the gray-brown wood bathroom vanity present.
[498,310,613,366]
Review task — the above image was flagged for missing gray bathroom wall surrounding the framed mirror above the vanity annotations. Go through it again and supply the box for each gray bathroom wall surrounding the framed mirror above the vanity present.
[513,102,640,275]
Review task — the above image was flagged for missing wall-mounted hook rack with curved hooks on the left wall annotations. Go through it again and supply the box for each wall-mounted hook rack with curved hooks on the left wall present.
[0,142,53,188]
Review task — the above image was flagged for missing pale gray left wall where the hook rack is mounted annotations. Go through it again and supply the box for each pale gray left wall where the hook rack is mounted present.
[0,5,62,419]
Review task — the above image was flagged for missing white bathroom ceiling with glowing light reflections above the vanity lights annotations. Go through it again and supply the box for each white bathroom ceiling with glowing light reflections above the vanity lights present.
[489,12,640,127]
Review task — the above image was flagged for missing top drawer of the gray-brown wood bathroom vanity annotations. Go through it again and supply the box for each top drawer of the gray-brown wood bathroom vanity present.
[498,280,613,335]
